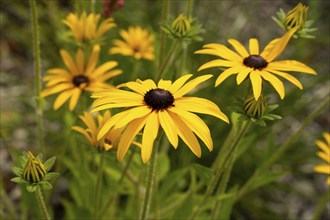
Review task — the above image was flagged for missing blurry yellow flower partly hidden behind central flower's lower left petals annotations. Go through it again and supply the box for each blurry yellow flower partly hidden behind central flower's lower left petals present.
[72,111,122,151]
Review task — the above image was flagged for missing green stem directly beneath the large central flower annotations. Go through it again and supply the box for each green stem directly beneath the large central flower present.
[139,138,161,220]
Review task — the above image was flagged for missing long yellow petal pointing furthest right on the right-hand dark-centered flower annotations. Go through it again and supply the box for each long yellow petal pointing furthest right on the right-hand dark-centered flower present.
[267,60,316,75]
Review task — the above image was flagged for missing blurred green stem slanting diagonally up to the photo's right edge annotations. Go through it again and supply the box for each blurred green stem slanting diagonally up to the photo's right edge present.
[236,97,330,201]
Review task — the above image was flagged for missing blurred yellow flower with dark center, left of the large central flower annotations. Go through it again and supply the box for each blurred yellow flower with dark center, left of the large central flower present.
[41,45,122,111]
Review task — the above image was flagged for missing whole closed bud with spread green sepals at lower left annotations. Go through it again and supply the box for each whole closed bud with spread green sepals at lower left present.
[11,151,58,192]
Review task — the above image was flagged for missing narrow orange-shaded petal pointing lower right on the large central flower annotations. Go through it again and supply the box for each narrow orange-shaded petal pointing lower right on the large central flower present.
[168,111,202,157]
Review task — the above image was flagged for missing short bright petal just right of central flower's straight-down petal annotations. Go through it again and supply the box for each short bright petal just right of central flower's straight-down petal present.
[158,110,179,149]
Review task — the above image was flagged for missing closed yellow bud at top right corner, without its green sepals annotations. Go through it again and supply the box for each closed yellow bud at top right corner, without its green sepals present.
[284,2,308,29]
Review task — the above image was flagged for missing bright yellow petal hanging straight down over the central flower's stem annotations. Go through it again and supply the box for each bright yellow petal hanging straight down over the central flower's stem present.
[141,112,159,163]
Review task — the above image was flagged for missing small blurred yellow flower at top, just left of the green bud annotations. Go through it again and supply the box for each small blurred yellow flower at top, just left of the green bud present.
[109,27,155,60]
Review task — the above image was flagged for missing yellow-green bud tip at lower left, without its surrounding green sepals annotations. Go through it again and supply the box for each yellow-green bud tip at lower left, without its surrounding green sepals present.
[23,151,46,183]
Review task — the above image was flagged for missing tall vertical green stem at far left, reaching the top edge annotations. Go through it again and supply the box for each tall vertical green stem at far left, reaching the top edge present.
[29,0,45,152]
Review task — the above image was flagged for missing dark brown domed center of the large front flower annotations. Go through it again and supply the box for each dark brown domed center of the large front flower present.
[144,89,174,110]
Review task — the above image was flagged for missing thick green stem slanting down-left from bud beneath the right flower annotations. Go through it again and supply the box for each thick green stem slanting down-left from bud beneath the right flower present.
[189,121,251,220]
